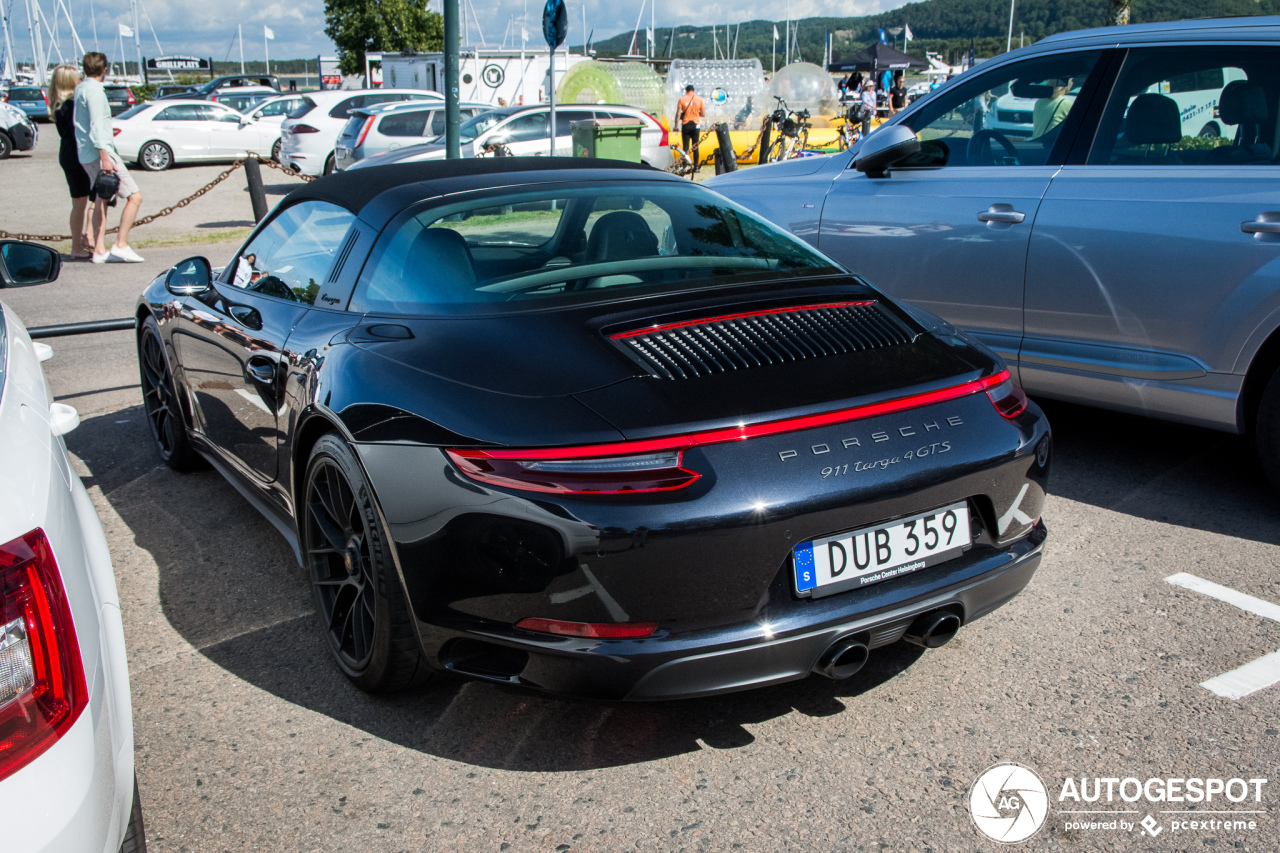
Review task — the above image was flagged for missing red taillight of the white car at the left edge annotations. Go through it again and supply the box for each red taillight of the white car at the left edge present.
[0,528,88,779]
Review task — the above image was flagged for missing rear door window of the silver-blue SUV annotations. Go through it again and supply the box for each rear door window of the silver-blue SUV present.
[1089,46,1280,165]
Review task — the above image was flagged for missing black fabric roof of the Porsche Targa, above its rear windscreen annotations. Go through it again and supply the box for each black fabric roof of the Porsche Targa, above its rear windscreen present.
[284,158,680,228]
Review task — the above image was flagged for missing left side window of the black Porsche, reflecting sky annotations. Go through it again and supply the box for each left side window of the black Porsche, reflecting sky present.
[228,201,356,305]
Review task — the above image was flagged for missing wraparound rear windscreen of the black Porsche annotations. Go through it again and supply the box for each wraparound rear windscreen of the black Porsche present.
[352,182,842,314]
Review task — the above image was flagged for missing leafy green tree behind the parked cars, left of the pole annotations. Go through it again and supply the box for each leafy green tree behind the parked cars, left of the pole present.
[324,0,444,74]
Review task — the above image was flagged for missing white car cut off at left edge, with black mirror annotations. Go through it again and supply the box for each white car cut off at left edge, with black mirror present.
[0,241,146,853]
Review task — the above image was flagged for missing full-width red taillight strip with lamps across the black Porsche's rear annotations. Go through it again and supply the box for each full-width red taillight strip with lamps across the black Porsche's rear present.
[445,370,1027,494]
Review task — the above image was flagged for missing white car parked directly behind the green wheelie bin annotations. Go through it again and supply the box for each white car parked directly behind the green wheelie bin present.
[347,104,671,169]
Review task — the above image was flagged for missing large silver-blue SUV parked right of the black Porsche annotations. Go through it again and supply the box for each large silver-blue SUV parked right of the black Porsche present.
[708,18,1280,487]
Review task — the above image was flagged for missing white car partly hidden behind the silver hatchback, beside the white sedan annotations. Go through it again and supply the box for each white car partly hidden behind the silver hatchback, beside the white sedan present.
[280,88,444,175]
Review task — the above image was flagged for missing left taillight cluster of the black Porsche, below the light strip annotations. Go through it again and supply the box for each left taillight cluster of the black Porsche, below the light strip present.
[448,447,701,494]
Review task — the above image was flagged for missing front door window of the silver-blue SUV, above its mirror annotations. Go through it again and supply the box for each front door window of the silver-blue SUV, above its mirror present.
[902,50,1101,168]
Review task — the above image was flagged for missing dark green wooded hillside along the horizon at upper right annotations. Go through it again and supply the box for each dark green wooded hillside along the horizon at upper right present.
[586,0,1280,69]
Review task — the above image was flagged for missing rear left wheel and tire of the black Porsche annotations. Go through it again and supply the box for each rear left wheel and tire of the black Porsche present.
[298,433,431,693]
